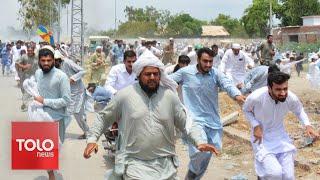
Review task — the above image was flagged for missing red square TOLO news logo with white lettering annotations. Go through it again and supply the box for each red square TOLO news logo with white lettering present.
[11,122,59,170]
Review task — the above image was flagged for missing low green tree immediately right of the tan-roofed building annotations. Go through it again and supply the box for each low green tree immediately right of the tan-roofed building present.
[210,14,248,37]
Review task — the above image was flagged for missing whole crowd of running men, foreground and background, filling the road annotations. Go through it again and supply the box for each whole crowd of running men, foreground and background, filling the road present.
[1,35,319,180]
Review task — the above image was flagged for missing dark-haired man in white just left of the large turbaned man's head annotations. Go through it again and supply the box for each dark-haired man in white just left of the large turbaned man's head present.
[104,50,137,94]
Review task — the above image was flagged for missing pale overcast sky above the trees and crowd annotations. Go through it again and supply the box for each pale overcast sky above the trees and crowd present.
[0,0,252,37]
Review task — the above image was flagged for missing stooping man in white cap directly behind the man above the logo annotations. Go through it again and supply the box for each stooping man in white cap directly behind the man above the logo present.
[54,50,89,139]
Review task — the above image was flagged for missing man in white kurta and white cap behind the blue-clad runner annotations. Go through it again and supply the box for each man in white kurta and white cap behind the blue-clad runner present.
[220,44,254,85]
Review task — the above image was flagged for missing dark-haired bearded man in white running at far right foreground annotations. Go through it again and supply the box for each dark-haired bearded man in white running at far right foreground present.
[243,72,319,180]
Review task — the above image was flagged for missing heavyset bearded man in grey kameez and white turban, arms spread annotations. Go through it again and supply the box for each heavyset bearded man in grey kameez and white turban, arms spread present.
[84,51,217,180]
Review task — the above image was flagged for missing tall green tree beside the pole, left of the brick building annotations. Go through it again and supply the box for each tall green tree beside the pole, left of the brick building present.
[242,0,279,37]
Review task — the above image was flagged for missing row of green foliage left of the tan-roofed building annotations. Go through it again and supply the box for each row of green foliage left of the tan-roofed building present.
[117,6,203,37]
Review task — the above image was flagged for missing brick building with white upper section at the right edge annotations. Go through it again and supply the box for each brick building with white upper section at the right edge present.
[272,16,320,44]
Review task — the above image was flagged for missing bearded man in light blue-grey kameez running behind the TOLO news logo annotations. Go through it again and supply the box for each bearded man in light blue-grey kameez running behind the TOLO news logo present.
[34,46,71,180]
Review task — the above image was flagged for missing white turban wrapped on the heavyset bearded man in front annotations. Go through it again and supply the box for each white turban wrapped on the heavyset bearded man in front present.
[132,49,178,92]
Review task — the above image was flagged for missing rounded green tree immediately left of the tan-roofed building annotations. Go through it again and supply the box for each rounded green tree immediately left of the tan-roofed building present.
[166,14,203,37]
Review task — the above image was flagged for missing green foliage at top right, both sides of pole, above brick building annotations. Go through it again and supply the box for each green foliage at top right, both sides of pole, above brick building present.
[242,0,320,37]
